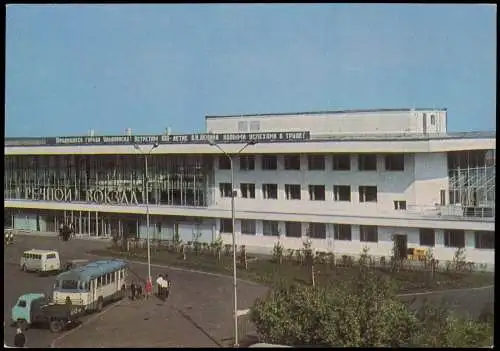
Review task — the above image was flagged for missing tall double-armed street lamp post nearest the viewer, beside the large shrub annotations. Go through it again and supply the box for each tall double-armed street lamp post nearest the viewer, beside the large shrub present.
[209,140,257,347]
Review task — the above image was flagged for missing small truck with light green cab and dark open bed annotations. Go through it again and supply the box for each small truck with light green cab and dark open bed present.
[12,293,83,333]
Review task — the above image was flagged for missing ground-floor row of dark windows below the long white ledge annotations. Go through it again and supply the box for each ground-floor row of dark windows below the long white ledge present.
[220,219,495,249]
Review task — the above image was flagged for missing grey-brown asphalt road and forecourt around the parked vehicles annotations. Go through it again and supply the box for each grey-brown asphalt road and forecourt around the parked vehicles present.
[4,236,494,347]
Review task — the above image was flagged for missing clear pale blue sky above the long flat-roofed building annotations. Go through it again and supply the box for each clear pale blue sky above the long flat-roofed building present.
[5,4,496,137]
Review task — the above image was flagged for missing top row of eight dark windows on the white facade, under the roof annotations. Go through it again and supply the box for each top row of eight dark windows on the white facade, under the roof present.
[219,154,405,171]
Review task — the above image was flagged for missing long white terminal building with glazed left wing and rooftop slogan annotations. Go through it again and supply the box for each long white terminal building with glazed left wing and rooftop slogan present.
[4,109,496,267]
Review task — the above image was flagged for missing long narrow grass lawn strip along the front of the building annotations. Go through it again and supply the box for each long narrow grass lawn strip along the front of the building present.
[90,247,494,293]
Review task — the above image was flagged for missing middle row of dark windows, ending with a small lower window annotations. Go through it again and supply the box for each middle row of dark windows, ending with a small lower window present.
[219,183,394,205]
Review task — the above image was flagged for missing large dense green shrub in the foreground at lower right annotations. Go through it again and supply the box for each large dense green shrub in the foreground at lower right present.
[250,266,493,347]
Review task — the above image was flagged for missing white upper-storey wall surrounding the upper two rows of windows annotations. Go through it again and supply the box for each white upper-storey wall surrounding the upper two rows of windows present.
[213,153,438,216]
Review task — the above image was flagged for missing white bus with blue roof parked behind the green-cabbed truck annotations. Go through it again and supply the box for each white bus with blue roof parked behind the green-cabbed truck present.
[53,260,128,312]
